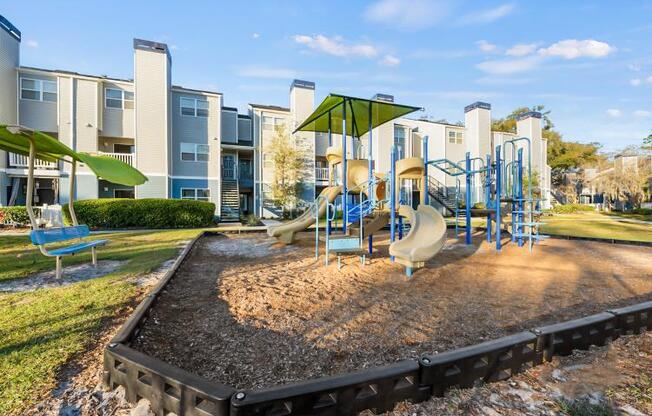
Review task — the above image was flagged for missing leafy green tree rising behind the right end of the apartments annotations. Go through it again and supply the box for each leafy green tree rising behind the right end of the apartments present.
[491,105,603,186]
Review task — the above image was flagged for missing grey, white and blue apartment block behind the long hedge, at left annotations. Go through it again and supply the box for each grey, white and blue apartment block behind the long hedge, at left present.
[0,16,254,218]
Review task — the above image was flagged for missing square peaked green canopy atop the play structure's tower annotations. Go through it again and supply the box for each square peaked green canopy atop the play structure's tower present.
[295,94,421,137]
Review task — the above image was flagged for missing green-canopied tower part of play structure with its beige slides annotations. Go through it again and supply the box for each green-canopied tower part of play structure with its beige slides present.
[268,94,446,276]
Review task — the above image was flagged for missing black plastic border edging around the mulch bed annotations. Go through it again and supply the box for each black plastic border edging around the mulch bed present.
[104,231,652,416]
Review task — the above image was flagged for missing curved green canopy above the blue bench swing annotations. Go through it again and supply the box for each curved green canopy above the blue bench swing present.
[0,125,147,186]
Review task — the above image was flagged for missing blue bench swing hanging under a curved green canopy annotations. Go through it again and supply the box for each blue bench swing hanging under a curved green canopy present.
[0,125,147,279]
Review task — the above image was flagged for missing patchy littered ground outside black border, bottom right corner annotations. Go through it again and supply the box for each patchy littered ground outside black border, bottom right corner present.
[389,332,652,416]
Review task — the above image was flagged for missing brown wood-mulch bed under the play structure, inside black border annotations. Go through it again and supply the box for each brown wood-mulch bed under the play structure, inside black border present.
[135,233,652,388]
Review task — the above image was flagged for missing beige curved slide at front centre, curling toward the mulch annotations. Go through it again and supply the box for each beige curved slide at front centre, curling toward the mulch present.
[389,204,446,277]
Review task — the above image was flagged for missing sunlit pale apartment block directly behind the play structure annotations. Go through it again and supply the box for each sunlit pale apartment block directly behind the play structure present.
[250,85,551,217]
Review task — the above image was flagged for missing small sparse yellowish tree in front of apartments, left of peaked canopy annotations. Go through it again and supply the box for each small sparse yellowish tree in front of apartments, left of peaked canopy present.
[266,126,310,212]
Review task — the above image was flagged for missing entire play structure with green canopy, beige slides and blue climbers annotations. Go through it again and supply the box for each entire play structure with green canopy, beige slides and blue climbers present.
[268,94,546,277]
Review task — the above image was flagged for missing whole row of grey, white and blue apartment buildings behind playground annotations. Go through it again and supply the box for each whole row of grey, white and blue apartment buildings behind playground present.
[0,16,550,220]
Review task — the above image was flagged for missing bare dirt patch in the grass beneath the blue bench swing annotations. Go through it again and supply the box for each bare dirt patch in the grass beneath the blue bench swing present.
[0,260,127,292]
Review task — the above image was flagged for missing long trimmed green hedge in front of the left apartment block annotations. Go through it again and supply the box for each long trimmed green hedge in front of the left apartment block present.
[63,198,215,228]
